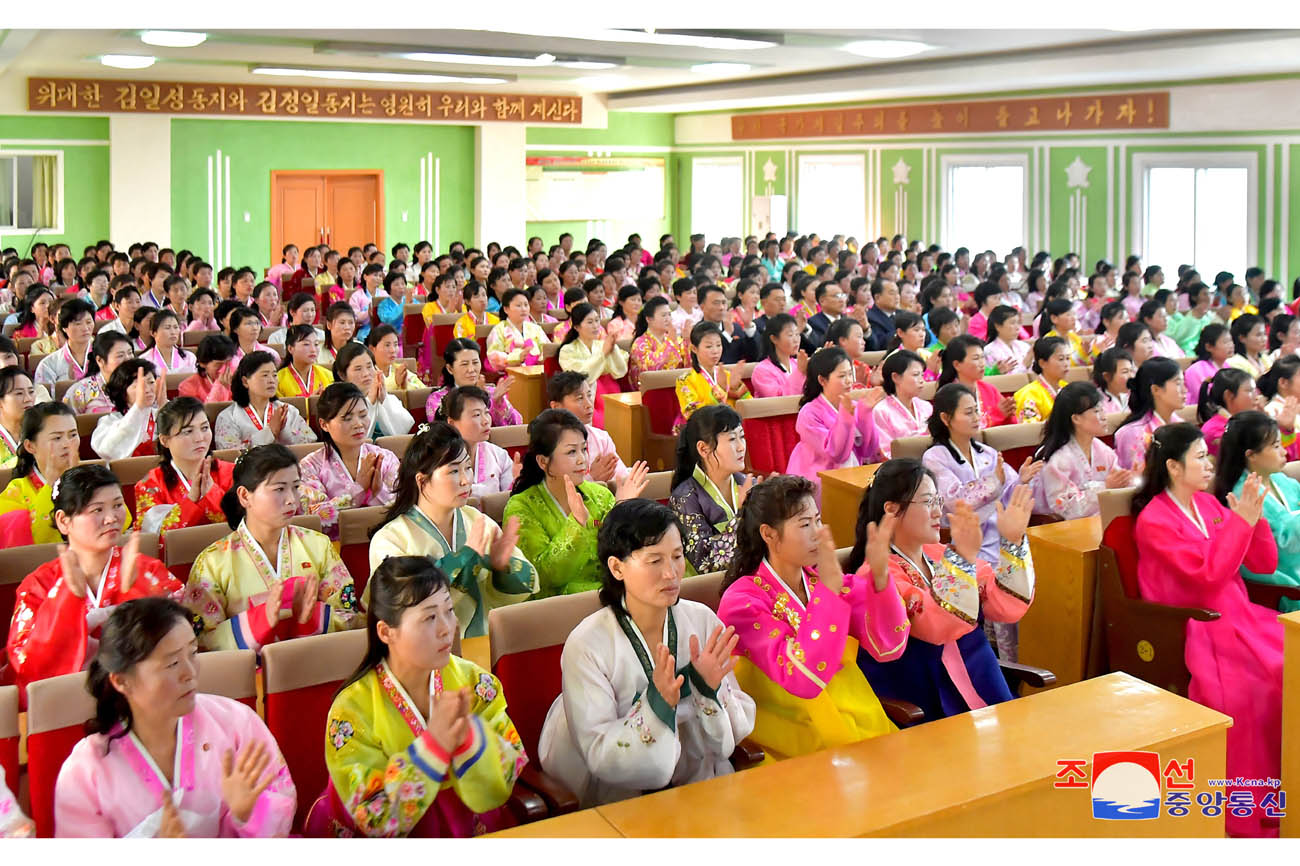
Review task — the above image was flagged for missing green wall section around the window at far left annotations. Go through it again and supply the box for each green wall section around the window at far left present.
[0,116,109,250]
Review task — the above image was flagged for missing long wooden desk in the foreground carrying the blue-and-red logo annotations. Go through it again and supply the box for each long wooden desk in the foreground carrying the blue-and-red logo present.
[595,674,1231,837]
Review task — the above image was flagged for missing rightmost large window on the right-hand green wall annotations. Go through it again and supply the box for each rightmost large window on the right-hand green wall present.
[1136,164,1255,282]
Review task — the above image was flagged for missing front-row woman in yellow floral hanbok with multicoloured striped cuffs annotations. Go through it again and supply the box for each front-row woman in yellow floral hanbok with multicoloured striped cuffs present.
[306,557,528,837]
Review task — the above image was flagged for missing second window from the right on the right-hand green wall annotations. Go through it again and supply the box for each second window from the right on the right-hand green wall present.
[943,153,1030,256]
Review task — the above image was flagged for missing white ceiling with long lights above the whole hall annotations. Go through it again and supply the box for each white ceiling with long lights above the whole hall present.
[0,27,1300,112]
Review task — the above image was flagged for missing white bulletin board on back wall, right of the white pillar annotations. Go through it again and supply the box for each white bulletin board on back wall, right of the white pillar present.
[525,156,664,222]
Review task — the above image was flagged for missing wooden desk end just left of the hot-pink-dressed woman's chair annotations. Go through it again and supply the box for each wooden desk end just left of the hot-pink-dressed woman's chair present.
[1019,516,1104,687]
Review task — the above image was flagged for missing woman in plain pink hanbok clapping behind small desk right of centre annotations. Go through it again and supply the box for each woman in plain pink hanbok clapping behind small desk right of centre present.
[785,346,884,503]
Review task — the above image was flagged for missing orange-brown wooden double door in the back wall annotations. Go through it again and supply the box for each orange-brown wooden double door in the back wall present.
[270,170,384,261]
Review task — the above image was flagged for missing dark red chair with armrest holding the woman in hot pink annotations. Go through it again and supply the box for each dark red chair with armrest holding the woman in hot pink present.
[1097,488,1219,697]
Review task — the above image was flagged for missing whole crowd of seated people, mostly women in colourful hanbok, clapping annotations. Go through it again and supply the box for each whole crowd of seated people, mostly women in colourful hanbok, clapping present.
[0,227,1300,836]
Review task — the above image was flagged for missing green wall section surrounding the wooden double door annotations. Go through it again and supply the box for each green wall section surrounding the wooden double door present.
[172,118,475,273]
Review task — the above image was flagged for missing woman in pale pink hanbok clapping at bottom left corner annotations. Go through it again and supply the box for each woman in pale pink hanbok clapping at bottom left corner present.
[55,597,298,839]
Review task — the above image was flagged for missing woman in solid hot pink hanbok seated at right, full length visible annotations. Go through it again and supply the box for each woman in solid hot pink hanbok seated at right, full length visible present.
[1134,424,1282,836]
